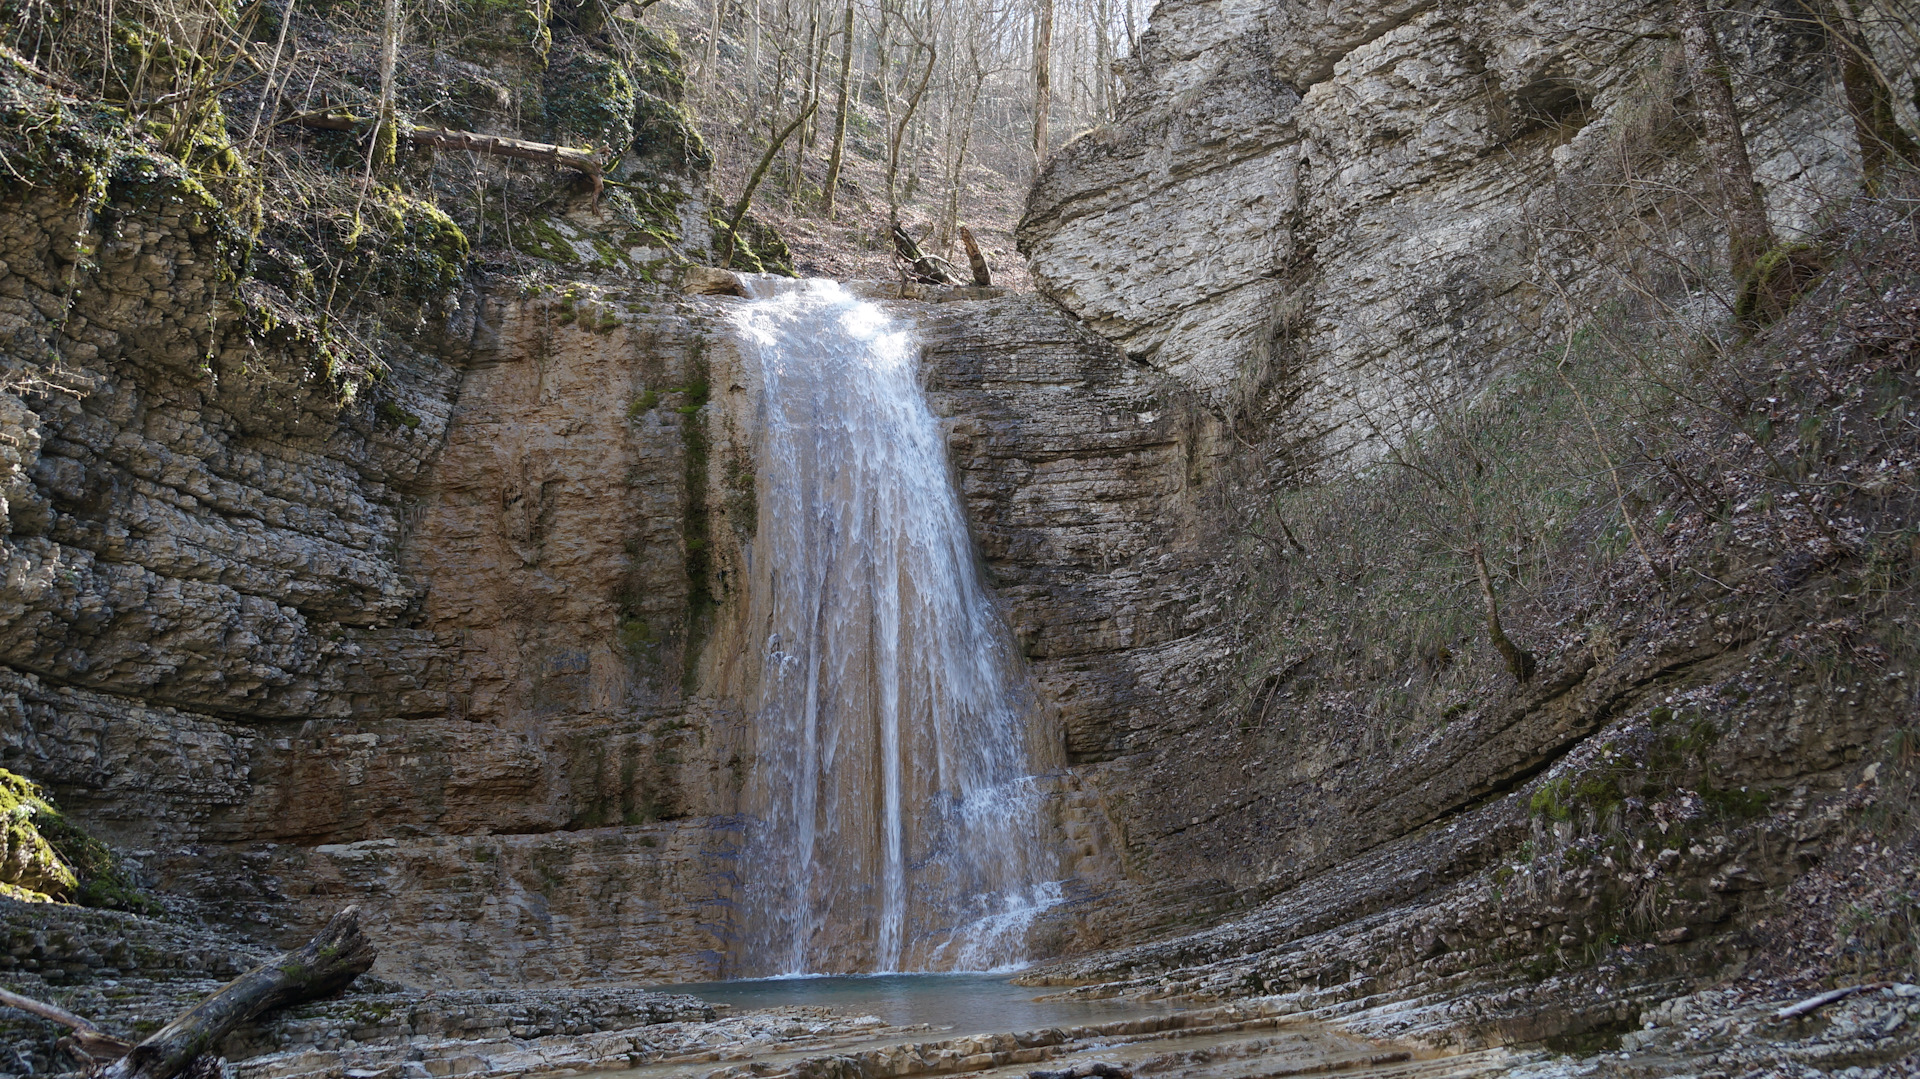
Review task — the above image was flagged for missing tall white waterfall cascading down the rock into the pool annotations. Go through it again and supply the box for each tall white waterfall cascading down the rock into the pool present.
[733,278,1058,975]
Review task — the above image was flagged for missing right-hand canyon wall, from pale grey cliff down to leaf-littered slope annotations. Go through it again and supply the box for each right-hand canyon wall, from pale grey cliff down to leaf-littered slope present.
[1021,0,1920,1041]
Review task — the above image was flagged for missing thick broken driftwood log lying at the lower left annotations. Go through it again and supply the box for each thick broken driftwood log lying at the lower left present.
[100,906,378,1079]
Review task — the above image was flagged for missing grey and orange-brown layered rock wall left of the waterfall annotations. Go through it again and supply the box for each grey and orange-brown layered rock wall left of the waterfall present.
[0,247,751,983]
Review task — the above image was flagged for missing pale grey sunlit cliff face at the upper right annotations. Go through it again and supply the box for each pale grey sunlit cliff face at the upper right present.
[1020,0,1858,470]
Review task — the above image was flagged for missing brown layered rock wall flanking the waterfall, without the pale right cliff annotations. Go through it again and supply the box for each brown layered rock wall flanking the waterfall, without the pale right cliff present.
[0,144,1213,985]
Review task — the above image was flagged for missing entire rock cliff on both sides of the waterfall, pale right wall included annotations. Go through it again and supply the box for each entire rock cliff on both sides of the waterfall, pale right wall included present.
[0,0,1920,1052]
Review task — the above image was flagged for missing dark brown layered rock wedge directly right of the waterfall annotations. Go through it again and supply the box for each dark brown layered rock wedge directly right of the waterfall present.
[920,298,1221,762]
